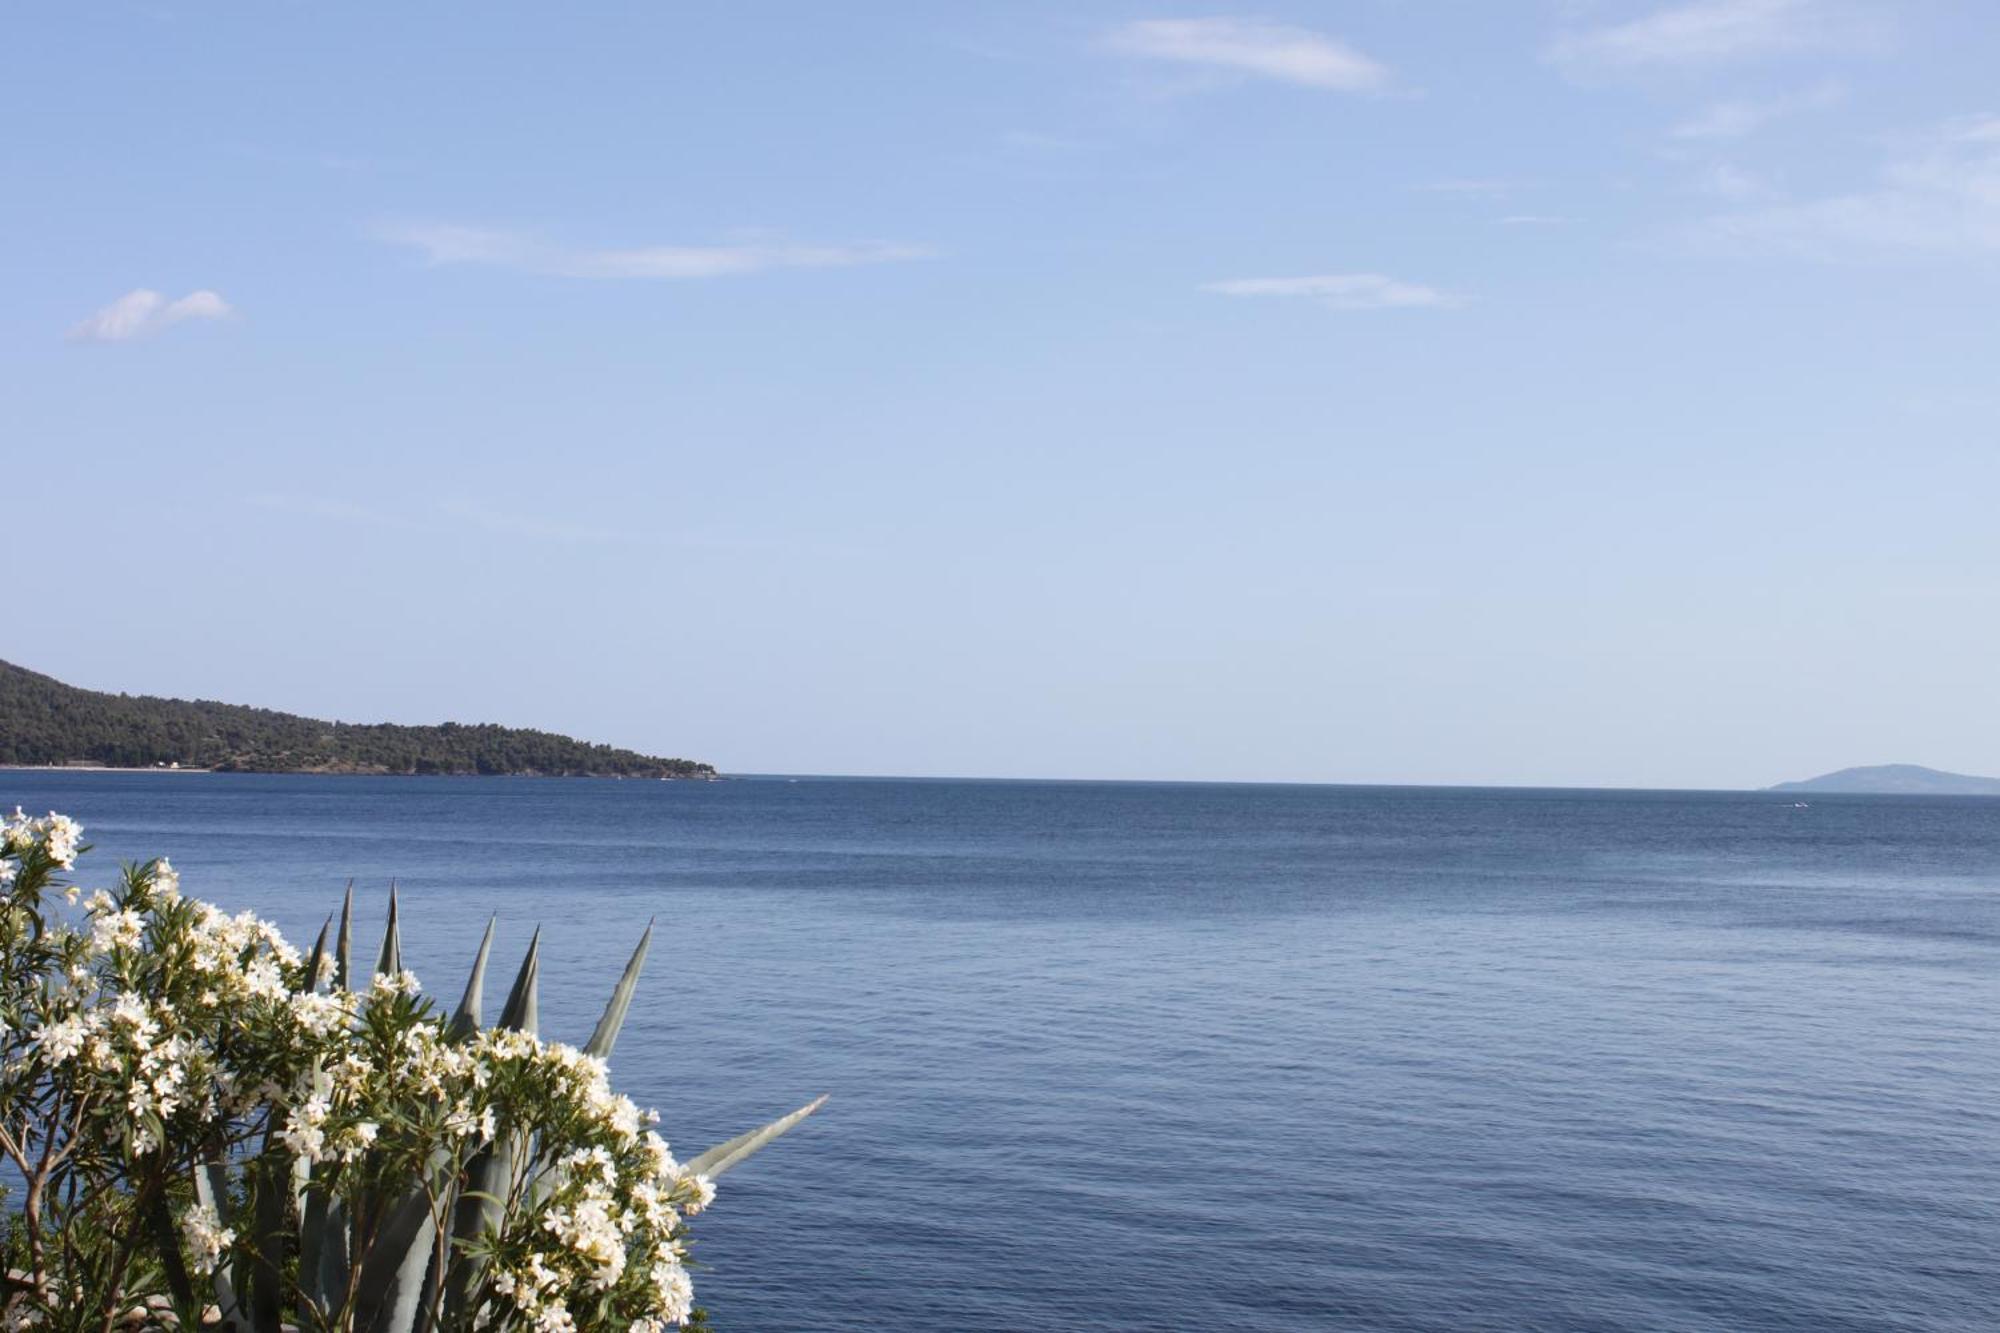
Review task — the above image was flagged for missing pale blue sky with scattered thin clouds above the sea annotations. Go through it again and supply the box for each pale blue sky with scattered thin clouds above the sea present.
[0,0,2000,787]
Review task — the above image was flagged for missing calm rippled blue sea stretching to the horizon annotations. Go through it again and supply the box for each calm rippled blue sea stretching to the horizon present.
[0,773,2000,1333]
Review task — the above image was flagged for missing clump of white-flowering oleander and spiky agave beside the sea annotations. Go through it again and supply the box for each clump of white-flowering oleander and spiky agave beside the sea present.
[0,811,824,1333]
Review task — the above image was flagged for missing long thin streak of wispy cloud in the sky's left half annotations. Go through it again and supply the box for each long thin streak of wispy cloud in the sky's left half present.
[374,222,932,280]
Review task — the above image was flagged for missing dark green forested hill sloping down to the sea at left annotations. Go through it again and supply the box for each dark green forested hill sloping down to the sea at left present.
[0,662,716,779]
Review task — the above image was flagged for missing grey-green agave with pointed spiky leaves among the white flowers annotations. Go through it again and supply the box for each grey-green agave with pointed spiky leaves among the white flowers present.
[180,885,826,1333]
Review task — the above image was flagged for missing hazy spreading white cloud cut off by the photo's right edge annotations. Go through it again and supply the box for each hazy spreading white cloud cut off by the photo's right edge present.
[1694,116,2000,258]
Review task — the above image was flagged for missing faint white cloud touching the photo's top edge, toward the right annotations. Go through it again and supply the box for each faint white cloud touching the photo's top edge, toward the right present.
[1548,0,1864,68]
